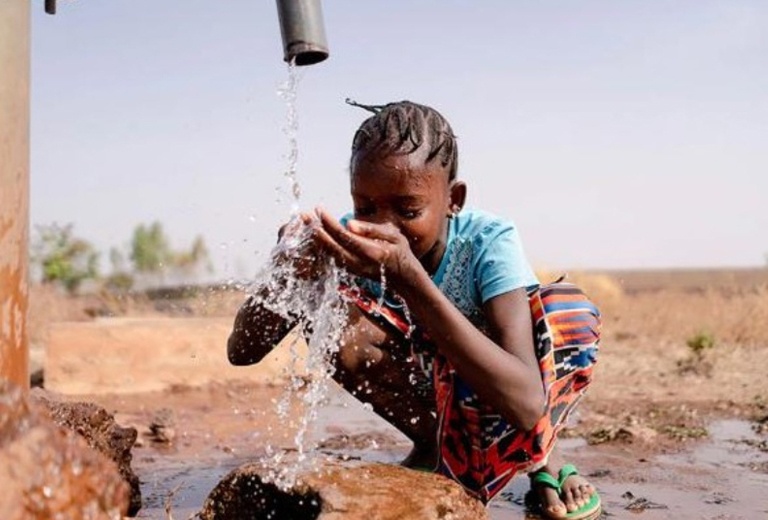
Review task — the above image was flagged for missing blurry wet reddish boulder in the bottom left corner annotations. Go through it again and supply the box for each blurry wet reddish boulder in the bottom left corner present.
[0,380,130,520]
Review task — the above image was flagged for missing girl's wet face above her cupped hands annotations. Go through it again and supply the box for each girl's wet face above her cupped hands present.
[351,150,463,273]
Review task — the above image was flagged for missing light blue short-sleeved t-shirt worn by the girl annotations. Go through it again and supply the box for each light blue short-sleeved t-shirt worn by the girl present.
[341,209,539,328]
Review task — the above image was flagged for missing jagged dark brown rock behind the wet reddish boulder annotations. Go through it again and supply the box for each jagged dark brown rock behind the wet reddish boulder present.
[31,389,141,516]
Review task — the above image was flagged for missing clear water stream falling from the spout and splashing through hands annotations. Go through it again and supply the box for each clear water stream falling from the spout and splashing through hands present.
[250,64,420,494]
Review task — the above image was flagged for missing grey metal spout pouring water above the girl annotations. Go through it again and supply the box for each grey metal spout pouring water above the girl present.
[277,0,328,65]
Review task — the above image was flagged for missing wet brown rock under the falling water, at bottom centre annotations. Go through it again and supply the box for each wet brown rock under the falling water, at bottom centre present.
[199,464,488,520]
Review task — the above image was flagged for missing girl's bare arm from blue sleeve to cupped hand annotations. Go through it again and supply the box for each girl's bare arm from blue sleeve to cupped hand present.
[315,212,545,429]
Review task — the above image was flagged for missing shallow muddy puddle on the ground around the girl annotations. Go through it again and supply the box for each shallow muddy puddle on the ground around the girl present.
[113,387,768,520]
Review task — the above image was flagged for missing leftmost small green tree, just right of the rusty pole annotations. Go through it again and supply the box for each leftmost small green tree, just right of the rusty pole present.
[31,223,99,294]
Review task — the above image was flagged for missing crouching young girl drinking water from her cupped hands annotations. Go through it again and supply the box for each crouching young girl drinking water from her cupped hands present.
[228,101,600,519]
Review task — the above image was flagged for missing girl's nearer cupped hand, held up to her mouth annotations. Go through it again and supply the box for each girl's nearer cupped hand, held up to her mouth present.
[313,209,421,284]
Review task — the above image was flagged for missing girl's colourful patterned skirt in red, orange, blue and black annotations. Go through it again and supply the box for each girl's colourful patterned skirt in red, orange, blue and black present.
[342,281,601,502]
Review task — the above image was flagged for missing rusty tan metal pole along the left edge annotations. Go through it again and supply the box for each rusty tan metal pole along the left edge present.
[0,0,31,389]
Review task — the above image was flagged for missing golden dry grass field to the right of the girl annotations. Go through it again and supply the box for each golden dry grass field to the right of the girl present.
[537,269,768,348]
